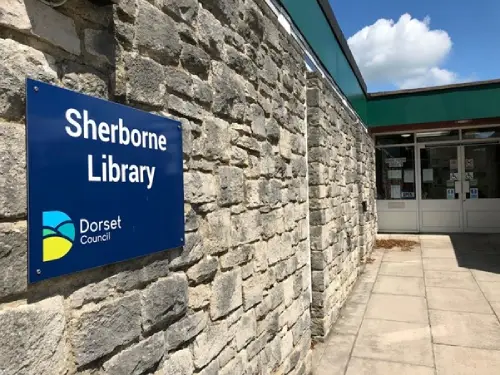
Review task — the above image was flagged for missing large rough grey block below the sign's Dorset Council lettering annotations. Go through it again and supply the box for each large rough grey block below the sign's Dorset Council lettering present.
[71,293,141,366]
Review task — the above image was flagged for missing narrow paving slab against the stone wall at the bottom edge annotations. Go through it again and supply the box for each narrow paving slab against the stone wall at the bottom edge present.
[313,335,356,375]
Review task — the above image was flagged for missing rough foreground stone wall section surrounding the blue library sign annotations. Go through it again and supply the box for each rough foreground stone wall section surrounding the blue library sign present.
[0,0,374,375]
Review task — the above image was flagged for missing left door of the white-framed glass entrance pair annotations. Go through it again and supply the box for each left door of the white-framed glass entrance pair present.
[418,146,464,233]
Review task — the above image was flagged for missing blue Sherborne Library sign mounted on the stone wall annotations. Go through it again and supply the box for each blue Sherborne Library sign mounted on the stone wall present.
[26,79,184,282]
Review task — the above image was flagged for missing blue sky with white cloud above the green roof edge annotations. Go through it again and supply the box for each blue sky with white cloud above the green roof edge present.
[330,0,500,92]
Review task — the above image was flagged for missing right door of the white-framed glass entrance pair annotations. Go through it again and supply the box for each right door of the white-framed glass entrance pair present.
[460,143,500,233]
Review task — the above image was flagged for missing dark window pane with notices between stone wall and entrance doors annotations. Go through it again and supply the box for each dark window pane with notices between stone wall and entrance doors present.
[376,146,415,199]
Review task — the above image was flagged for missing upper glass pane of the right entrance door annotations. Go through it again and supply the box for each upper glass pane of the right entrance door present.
[464,144,500,199]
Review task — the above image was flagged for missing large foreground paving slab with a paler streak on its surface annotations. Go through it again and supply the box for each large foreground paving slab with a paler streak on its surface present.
[352,319,434,366]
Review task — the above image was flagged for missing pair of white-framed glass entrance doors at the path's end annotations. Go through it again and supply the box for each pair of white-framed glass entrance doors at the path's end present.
[417,143,500,233]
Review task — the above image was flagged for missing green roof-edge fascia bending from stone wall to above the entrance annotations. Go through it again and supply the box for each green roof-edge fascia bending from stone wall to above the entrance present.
[278,0,500,127]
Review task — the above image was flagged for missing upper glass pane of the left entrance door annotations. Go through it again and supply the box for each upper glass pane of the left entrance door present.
[420,146,459,199]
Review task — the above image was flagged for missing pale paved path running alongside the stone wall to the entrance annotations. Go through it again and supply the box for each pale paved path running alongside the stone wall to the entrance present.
[313,235,500,375]
